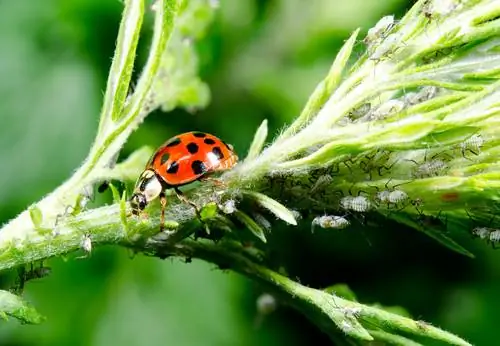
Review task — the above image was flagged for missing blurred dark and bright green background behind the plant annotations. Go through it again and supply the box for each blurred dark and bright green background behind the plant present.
[0,0,500,346]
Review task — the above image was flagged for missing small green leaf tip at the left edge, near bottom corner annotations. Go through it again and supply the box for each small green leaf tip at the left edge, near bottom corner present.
[0,290,45,324]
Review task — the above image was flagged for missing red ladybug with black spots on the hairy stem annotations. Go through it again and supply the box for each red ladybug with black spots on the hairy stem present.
[130,131,238,230]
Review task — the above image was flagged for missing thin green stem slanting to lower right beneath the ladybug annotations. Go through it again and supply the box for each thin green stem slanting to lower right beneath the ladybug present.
[147,239,470,346]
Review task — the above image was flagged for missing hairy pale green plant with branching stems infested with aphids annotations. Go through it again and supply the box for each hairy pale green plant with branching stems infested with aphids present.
[0,0,500,345]
